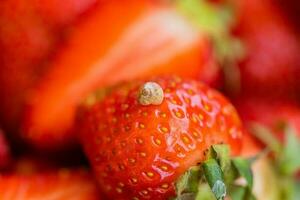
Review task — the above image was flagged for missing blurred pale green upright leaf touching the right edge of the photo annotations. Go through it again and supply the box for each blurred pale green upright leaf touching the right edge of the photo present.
[280,126,300,175]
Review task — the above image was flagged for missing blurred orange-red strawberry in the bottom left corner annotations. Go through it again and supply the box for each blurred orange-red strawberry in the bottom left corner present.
[0,169,100,200]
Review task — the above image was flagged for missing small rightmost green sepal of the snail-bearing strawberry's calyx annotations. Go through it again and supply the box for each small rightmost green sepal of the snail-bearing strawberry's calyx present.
[232,158,253,190]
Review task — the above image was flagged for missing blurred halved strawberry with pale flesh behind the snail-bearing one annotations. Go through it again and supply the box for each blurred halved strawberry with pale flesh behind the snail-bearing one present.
[22,0,234,149]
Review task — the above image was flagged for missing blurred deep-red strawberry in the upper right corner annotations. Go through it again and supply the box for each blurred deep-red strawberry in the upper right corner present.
[236,0,300,96]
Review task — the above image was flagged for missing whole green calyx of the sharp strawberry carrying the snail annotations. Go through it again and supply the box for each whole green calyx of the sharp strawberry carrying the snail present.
[173,144,254,200]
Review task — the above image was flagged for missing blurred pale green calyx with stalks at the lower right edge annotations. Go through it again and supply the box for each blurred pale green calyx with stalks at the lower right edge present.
[251,123,300,200]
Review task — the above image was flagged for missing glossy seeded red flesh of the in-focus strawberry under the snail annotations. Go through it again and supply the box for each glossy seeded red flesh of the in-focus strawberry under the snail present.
[76,77,242,200]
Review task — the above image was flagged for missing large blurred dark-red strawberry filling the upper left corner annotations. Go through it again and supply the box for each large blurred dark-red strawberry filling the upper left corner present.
[0,0,95,134]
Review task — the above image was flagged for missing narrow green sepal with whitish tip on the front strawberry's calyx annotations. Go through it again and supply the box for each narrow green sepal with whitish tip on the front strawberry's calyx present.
[202,159,226,200]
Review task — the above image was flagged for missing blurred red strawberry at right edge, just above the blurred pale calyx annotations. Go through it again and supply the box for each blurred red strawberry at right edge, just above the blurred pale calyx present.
[235,98,300,139]
